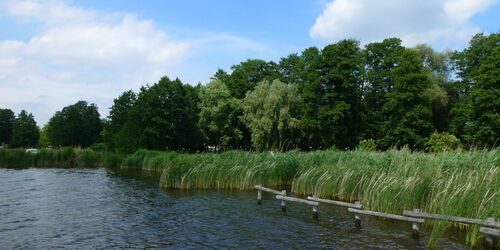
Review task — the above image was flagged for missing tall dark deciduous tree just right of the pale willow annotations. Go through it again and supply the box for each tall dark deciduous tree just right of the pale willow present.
[314,40,363,149]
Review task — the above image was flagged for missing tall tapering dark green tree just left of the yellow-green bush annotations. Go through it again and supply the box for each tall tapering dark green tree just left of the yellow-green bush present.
[381,49,434,149]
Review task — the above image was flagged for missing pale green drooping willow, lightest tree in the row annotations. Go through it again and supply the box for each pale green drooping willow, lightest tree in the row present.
[242,80,301,150]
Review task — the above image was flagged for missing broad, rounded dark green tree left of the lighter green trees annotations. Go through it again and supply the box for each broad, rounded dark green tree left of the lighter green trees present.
[118,77,203,151]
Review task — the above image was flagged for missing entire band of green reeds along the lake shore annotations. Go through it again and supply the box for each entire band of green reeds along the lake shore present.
[0,149,500,246]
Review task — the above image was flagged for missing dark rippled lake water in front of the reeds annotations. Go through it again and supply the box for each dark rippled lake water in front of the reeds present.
[0,169,466,249]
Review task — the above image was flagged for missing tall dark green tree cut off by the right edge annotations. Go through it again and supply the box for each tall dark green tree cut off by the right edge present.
[451,33,500,147]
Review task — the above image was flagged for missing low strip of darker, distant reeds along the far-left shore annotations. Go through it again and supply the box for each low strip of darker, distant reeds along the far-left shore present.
[0,148,124,168]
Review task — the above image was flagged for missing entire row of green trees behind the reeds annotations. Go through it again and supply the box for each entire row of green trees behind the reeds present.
[0,33,500,152]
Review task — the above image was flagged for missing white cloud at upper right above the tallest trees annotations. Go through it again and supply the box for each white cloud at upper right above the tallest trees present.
[310,0,496,48]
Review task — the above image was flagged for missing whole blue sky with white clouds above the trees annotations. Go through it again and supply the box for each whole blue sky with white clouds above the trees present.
[0,0,500,126]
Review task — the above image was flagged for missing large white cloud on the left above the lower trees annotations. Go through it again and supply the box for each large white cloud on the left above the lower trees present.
[0,0,270,125]
